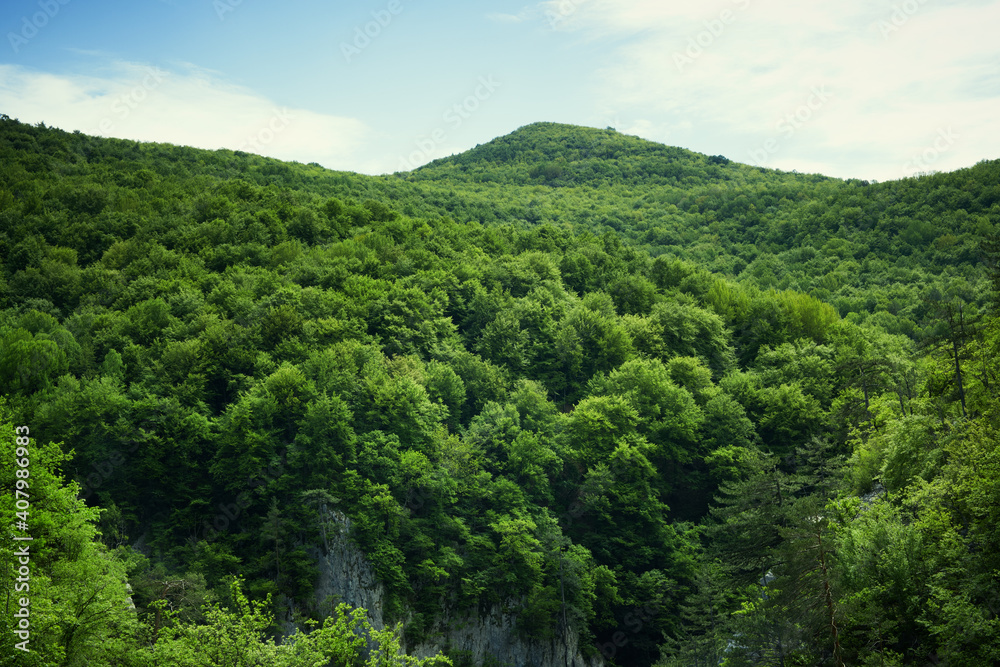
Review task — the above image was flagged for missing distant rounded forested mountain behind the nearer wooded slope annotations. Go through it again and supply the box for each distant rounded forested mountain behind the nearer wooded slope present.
[405,123,1000,336]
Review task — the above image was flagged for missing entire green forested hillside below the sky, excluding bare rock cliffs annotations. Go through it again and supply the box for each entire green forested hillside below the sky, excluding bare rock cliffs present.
[0,117,1000,665]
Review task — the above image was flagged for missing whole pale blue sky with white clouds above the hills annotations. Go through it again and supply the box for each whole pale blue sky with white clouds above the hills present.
[0,0,1000,181]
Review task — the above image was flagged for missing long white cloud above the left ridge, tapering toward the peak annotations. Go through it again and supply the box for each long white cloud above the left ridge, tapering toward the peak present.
[0,62,372,169]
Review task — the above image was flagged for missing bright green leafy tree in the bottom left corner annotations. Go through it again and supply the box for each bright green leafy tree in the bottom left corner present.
[0,401,136,666]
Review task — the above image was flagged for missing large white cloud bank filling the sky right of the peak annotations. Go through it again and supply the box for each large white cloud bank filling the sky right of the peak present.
[539,0,1000,180]
